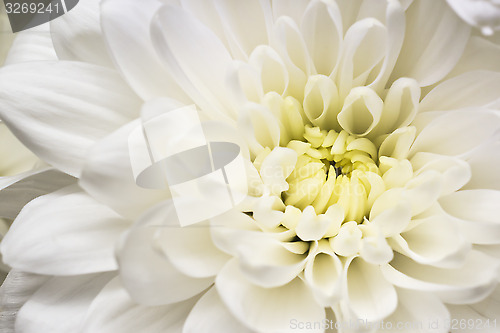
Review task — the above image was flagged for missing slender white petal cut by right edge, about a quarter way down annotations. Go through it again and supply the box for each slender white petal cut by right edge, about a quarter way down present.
[419,71,500,112]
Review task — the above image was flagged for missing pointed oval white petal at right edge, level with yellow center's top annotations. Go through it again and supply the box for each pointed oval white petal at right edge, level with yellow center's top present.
[410,109,500,156]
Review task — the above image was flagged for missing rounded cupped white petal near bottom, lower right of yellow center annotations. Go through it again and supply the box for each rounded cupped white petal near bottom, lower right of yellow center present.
[346,258,398,321]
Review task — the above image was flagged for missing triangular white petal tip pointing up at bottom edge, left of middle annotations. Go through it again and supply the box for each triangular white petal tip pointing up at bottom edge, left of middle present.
[182,288,253,333]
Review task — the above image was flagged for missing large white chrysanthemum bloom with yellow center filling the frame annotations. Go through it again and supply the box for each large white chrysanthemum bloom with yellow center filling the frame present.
[0,0,500,332]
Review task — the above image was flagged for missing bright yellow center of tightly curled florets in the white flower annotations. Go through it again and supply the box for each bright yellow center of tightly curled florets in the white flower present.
[282,125,380,223]
